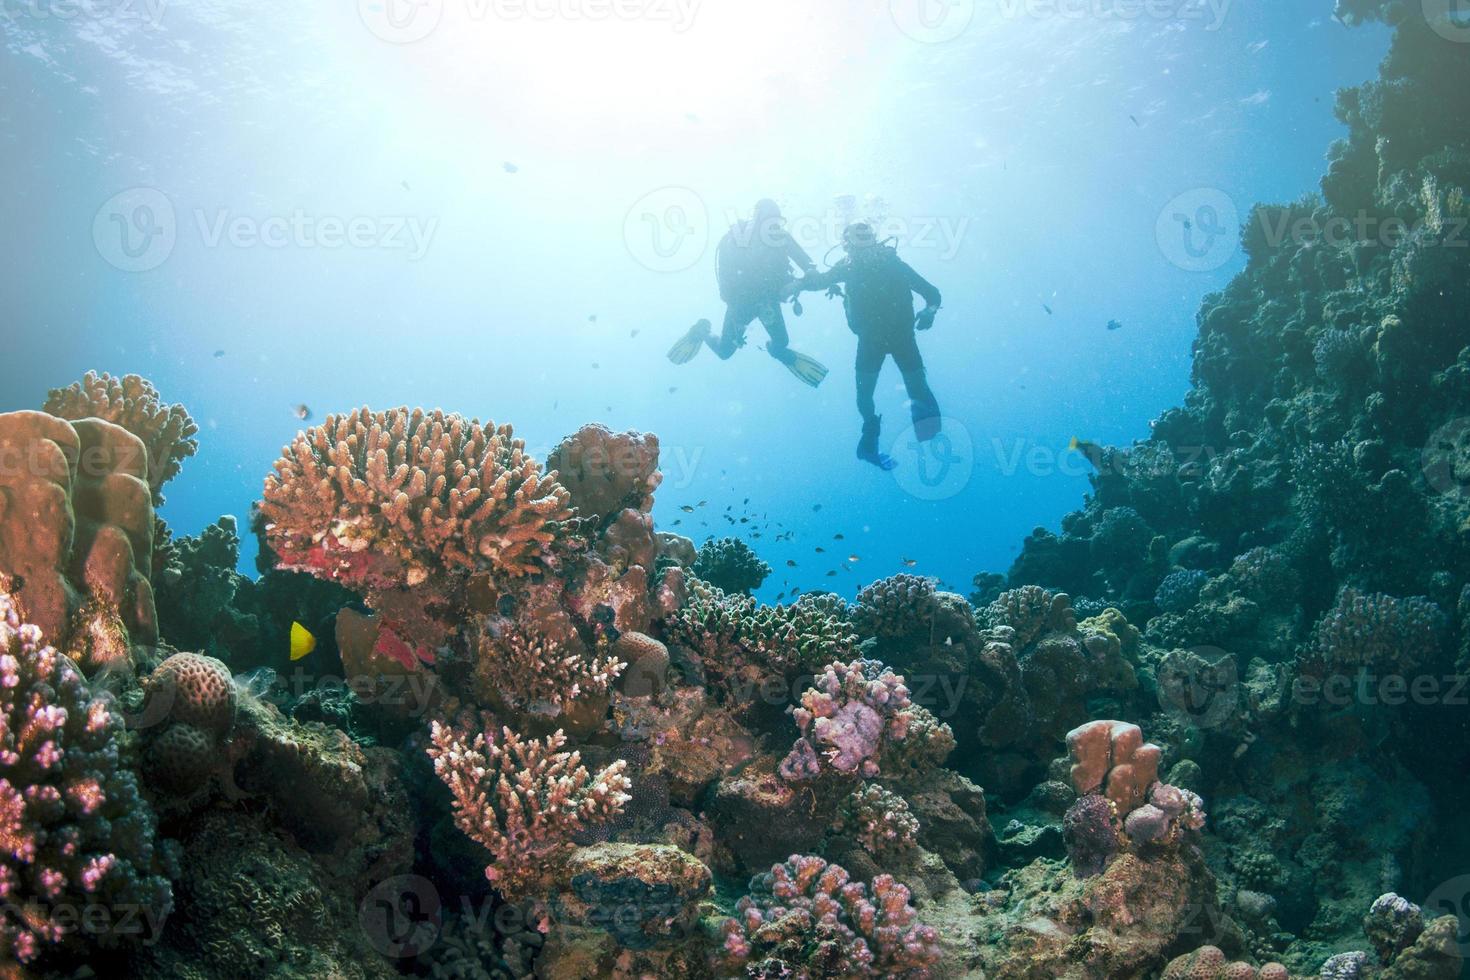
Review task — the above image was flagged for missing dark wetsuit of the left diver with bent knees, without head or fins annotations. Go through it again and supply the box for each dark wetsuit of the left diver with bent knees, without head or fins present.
[707,222,816,364]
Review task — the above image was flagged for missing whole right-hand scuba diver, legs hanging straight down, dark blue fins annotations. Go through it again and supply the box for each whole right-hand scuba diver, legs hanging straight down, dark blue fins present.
[786,223,941,470]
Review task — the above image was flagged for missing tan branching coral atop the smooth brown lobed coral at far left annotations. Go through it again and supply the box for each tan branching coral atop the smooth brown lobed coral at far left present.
[44,372,198,505]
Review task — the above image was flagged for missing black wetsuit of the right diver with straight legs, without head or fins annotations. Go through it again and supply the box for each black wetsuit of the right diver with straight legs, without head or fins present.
[801,245,941,425]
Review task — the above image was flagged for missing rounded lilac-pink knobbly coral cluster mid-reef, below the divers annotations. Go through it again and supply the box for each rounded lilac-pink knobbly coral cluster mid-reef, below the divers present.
[781,660,913,780]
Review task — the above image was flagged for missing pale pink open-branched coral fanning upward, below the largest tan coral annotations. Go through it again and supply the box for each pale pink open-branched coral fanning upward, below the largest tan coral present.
[429,721,632,898]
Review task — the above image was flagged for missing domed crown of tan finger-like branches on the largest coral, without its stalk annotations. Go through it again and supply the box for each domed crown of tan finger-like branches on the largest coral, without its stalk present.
[260,408,572,585]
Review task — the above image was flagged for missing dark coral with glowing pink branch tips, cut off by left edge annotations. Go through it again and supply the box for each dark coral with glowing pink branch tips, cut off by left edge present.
[0,592,172,962]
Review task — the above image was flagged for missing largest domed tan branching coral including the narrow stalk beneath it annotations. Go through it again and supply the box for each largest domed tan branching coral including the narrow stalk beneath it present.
[260,408,572,667]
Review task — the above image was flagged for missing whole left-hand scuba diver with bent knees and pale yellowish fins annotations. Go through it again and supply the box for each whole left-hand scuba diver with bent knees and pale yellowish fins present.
[669,200,828,388]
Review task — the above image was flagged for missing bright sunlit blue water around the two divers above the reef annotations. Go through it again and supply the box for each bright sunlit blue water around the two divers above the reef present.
[0,0,1388,598]
